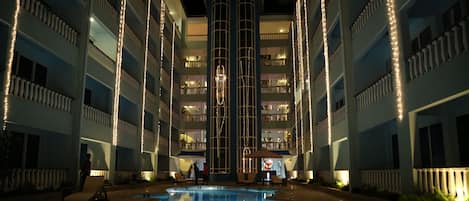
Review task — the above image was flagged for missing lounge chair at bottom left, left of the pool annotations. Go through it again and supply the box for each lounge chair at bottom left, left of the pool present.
[64,176,107,201]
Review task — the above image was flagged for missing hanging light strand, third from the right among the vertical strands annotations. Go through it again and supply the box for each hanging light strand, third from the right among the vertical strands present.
[303,0,313,152]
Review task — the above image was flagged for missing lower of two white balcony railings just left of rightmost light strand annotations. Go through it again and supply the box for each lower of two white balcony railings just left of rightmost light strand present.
[355,72,394,110]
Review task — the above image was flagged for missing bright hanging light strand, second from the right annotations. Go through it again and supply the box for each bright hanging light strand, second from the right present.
[321,0,332,146]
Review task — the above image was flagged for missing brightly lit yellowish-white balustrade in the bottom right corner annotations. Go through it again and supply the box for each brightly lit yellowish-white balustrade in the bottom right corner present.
[414,167,469,198]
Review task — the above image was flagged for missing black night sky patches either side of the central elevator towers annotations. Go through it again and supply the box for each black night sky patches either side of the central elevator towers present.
[182,0,295,17]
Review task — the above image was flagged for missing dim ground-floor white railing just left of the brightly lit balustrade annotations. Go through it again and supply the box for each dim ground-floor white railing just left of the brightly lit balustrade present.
[361,169,401,193]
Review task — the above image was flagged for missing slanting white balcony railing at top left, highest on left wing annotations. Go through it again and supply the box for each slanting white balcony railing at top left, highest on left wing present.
[21,0,78,46]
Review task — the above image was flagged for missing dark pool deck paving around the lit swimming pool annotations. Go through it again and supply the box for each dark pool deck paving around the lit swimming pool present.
[0,182,384,201]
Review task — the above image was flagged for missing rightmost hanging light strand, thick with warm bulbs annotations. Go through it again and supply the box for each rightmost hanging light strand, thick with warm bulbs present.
[386,0,404,121]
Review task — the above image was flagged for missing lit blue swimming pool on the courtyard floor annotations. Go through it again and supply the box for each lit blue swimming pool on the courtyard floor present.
[145,186,275,201]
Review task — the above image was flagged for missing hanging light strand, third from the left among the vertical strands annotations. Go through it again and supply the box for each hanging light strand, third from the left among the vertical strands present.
[140,0,151,153]
